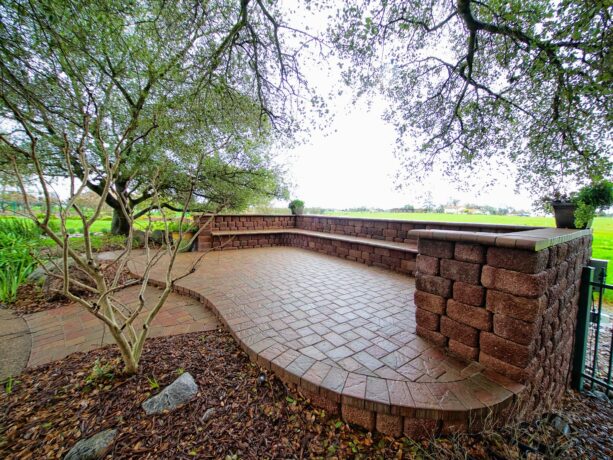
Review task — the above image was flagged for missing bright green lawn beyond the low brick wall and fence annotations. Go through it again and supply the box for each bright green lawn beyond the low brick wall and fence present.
[327,212,613,303]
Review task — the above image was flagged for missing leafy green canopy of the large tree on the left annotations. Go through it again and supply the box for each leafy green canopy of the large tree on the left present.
[0,0,304,232]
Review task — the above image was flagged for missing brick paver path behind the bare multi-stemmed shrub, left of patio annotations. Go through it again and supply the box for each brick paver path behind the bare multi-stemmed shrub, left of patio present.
[24,286,219,367]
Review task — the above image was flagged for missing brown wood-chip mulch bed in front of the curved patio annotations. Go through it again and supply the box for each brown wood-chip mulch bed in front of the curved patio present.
[0,330,613,459]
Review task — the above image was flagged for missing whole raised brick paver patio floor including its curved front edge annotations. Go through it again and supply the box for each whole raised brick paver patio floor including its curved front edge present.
[131,247,521,434]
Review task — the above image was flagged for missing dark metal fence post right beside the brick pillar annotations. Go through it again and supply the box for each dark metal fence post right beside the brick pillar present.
[571,267,595,391]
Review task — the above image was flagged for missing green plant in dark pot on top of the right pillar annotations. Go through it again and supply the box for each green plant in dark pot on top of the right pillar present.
[546,180,613,228]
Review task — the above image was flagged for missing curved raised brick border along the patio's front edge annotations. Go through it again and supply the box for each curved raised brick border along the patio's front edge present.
[128,250,525,437]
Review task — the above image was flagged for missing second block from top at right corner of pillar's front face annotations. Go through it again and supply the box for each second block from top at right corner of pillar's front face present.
[481,265,548,298]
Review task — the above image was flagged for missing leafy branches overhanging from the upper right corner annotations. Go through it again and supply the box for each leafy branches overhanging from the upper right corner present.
[330,0,613,194]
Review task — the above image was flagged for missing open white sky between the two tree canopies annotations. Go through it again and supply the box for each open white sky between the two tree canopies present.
[278,2,532,209]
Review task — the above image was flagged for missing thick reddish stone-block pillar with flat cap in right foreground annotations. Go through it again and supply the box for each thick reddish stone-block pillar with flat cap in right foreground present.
[408,229,592,416]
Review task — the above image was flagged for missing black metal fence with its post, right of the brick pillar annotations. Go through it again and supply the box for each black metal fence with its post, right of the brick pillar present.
[572,261,613,395]
